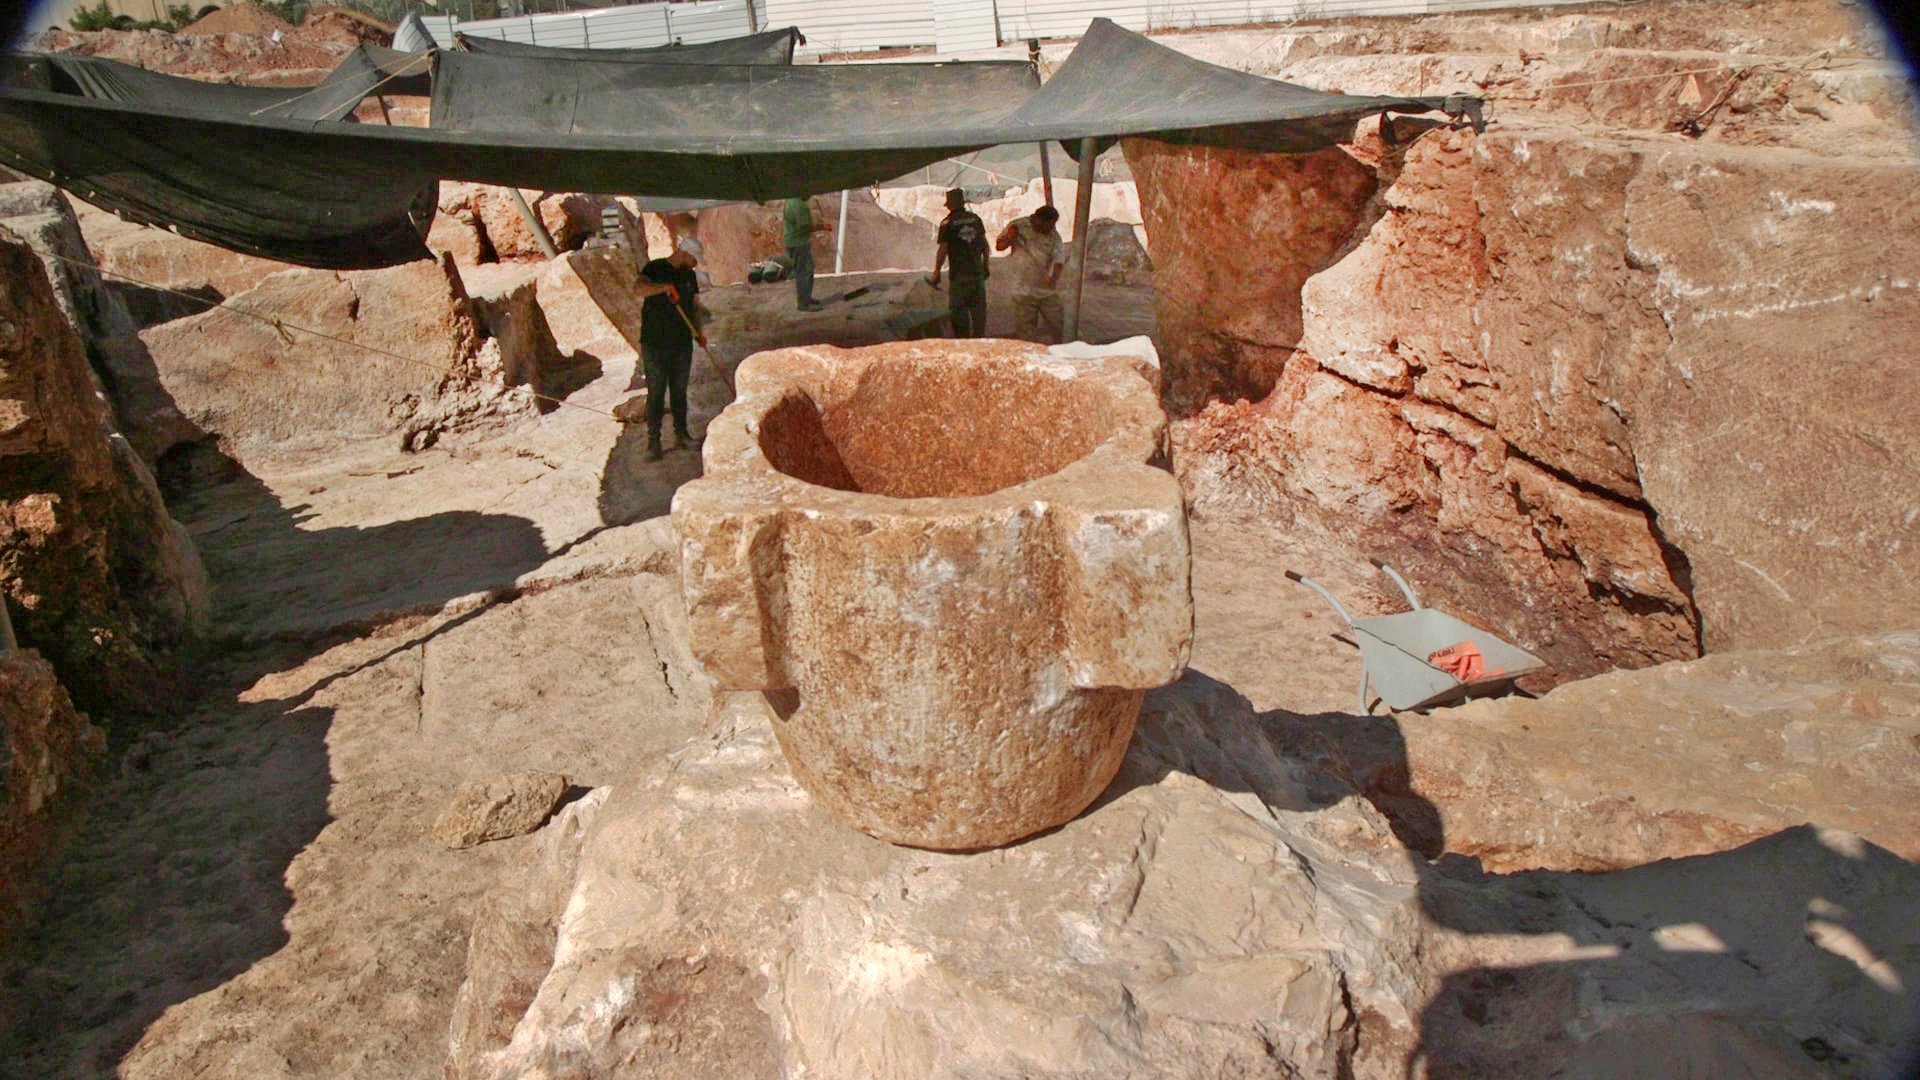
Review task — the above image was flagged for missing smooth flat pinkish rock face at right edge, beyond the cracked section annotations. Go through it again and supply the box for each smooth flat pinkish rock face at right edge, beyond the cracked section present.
[1626,150,1920,650]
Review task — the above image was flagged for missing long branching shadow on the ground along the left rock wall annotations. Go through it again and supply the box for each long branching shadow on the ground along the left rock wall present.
[0,434,576,1076]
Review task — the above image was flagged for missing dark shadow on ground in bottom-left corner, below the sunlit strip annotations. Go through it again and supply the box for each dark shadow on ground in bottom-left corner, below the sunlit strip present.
[0,687,332,1076]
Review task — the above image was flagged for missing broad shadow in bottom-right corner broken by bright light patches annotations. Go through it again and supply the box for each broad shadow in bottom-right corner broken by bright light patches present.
[1409,824,1920,1076]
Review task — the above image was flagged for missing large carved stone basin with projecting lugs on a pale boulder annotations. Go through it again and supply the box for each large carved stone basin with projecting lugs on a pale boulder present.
[674,338,1192,849]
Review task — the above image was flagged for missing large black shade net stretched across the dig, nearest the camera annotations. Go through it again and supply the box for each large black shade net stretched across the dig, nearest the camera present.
[0,19,1448,269]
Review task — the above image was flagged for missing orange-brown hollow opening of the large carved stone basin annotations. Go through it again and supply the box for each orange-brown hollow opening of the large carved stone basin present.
[760,357,1114,498]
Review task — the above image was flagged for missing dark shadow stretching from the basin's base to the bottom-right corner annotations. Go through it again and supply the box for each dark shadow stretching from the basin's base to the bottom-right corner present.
[1113,673,1920,1078]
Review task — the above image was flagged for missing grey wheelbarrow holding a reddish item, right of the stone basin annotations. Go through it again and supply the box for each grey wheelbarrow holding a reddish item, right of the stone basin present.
[1286,559,1546,715]
